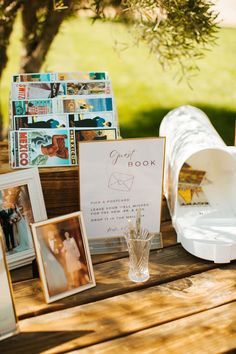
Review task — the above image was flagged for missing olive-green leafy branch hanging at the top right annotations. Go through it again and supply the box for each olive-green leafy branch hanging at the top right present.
[125,0,218,74]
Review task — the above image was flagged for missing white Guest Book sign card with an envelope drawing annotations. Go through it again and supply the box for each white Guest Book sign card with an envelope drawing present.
[79,138,165,246]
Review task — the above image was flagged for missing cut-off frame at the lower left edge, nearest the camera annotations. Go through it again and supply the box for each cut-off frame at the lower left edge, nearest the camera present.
[0,230,19,340]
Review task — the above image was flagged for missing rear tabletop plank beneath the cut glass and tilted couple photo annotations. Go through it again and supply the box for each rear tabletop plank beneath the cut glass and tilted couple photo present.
[13,245,217,319]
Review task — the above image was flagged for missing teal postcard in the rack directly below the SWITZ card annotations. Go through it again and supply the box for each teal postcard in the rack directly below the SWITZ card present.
[12,99,52,116]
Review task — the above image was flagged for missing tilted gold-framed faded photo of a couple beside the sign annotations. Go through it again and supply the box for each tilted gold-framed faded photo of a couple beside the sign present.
[31,212,96,303]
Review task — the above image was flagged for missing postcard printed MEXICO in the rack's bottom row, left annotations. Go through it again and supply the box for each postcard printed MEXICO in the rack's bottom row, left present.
[10,129,77,168]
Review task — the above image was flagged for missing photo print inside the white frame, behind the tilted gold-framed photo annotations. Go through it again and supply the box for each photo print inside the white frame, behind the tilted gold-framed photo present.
[0,185,34,255]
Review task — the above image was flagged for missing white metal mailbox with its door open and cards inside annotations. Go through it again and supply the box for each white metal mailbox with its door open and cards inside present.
[160,106,236,263]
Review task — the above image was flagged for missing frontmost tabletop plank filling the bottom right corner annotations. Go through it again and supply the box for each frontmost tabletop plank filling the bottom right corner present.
[76,302,236,354]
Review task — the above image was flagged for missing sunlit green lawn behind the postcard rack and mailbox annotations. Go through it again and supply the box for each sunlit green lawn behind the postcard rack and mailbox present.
[1,14,236,145]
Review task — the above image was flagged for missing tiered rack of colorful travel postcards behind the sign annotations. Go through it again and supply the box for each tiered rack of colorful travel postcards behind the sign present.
[9,72,119,168]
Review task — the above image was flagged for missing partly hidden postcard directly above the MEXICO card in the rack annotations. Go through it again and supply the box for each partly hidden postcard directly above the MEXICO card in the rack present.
[13,113,69,130]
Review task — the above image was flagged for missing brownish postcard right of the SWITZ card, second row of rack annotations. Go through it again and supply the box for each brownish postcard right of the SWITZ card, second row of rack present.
[66,81,111,96]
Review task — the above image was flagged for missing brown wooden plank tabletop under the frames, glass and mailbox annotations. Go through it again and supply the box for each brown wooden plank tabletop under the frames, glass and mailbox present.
[0,142,236,354]
